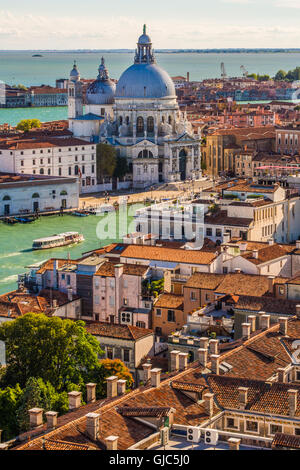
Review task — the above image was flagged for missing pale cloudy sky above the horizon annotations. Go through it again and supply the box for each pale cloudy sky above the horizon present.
[0,0,300,50]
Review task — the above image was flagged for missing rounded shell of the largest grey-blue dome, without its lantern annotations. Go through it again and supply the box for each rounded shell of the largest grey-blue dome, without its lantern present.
[116,63,176,98]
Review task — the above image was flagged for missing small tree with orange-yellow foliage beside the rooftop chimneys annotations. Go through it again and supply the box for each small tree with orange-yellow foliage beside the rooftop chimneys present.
[92,359,133,398]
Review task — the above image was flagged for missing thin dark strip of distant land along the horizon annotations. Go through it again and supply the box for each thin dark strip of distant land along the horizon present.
[0,48,300,54]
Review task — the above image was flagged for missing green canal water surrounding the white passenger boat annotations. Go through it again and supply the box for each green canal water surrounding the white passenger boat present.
[0,213,134,294]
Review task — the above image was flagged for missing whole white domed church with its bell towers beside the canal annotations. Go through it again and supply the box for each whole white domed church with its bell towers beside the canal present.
[69,26,201,188]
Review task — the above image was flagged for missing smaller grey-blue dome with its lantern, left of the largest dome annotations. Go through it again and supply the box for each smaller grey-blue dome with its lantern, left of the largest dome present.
[86,57,116,105]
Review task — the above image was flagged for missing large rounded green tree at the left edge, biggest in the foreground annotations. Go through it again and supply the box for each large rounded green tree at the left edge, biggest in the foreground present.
[0,313,103,392]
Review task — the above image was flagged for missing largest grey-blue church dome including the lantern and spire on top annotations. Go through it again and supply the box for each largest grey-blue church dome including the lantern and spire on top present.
[116,26,176,99]
